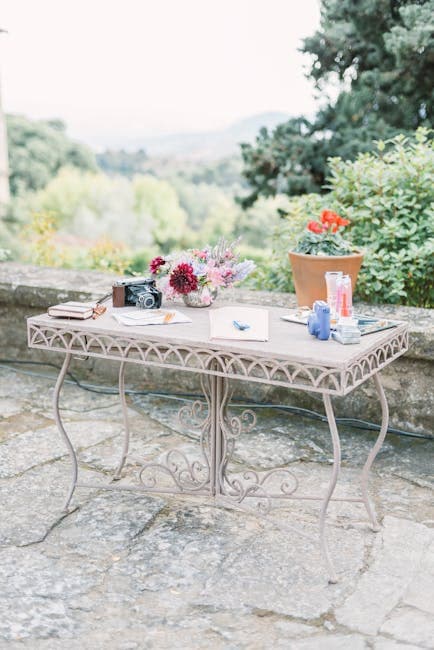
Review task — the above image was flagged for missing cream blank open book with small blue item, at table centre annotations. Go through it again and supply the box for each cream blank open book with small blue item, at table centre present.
[209,305,269,341]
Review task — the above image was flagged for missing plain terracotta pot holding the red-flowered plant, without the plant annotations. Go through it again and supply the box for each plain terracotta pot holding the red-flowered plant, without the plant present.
[288,251,363,307]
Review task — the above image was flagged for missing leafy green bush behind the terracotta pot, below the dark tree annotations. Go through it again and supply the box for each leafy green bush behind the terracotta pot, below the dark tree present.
[263,128,434,307]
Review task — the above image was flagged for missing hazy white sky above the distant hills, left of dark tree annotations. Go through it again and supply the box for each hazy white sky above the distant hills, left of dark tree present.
[0,0,319,145]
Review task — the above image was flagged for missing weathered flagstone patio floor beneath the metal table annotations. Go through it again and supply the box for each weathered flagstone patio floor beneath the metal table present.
[0,366,434,650]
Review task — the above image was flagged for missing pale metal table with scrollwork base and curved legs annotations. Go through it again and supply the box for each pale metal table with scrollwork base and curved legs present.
[28,307,408,582]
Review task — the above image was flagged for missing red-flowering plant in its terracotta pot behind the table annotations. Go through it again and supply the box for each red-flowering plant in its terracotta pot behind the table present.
[288,210,363,307]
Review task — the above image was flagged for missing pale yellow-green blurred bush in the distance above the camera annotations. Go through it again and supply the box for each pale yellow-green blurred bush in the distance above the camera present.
[16,167,187,252]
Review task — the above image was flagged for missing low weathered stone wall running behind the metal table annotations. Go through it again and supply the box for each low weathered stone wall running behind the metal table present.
[0,262,434,435]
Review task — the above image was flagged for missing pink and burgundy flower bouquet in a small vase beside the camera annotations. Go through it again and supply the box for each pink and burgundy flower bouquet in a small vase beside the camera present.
[149,239,255,307]
